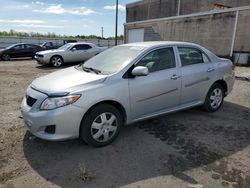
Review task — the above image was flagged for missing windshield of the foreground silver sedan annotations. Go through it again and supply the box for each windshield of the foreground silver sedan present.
[82,46,145,74]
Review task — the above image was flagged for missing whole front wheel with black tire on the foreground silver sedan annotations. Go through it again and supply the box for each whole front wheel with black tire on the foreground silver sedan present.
[80,104,123,147]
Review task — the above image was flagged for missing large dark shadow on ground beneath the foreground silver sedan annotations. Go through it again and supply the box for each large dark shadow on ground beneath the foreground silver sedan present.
[23,102,250,187]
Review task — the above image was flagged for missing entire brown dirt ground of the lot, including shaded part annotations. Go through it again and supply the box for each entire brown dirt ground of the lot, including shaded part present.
[0,60,250,188]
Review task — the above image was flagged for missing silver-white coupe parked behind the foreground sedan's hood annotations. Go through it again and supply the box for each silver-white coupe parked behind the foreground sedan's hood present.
[35,42,106,67]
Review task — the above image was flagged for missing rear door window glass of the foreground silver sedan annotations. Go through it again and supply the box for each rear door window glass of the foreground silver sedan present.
[178,47,209,66]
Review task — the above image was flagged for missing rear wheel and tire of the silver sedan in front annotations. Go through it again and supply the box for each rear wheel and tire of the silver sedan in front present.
[203,83,225,112]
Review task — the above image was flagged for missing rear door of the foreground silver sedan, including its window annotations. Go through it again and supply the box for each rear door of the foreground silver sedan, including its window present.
[178,47,215,105]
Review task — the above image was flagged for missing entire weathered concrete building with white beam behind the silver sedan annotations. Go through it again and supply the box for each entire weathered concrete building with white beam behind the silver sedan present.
[125,0,250,61]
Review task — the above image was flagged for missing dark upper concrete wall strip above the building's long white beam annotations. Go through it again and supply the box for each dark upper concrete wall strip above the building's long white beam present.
[126,0,250,23]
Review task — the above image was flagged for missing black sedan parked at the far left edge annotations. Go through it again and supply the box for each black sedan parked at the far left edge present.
[0,43,44,61]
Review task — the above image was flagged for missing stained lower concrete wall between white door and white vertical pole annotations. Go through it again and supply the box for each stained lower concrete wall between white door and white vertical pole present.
[126,12,237,56]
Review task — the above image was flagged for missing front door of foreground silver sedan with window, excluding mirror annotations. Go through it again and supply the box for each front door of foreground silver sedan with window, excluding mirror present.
[129,47,181,119]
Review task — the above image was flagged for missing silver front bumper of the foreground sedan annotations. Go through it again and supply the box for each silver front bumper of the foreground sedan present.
[21,88,85,141]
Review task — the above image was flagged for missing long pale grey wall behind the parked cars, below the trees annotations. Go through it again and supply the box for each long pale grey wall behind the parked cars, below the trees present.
[0,36,123,48]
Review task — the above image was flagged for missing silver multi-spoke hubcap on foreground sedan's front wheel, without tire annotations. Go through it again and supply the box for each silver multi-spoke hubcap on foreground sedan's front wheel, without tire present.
[91,112,117,142]
